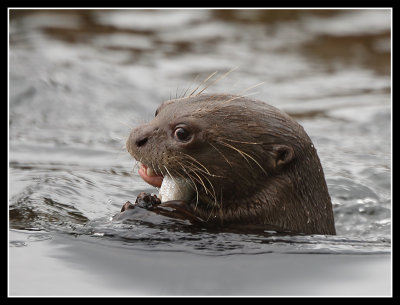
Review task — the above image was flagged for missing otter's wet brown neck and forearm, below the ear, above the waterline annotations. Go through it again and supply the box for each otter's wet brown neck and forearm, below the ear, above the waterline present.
[192,146,336,235]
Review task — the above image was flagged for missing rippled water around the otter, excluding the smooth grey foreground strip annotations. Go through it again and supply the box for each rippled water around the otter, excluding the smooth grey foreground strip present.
[9,10,391,254]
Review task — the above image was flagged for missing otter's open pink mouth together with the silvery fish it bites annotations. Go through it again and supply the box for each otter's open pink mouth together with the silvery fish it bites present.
[139,163,193,202]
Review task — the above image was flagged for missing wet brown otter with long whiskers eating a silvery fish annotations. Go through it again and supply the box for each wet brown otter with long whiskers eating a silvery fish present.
[122,94,335,235]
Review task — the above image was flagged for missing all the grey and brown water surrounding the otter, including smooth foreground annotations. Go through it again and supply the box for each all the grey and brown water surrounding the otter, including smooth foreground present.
[9,10,391,295]
